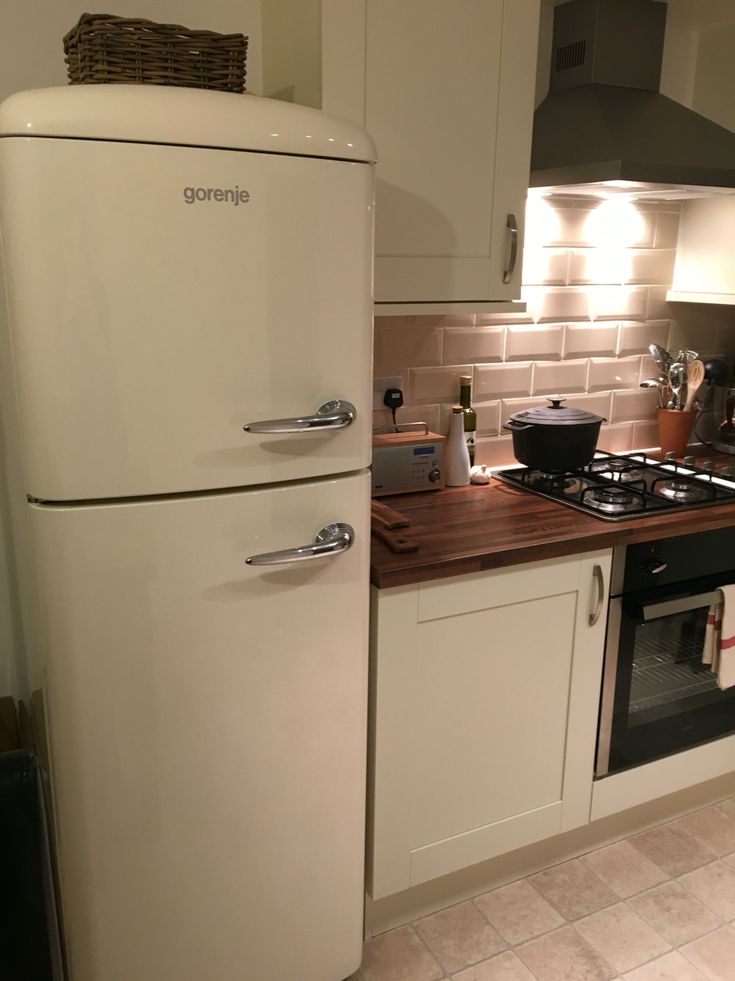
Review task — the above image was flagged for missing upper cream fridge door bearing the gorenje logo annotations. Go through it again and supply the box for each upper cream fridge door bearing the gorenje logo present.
[0,137,374,501]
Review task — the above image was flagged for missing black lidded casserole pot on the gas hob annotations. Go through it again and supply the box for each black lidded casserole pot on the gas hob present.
[503,396,605,473]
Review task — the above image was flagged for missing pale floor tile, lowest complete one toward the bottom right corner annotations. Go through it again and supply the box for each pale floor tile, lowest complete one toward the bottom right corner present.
[575,903,671,973]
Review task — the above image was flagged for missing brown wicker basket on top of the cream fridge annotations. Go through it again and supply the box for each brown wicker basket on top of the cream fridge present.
[64,14,248,92]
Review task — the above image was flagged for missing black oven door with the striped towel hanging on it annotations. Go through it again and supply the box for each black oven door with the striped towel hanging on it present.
[595,574,735,777]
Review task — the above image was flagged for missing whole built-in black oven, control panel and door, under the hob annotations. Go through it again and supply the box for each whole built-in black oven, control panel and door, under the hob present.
[595,528,735,777]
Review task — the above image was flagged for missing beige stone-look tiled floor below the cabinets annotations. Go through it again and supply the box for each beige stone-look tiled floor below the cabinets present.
[352,797,735,981]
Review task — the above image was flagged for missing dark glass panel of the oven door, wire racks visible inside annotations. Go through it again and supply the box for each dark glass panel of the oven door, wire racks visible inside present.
[608,598,735,773]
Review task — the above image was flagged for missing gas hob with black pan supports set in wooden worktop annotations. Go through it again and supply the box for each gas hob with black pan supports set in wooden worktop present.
[494,453,735,521]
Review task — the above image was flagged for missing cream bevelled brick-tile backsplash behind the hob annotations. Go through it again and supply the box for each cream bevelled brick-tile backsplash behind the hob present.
[374,197,735,466]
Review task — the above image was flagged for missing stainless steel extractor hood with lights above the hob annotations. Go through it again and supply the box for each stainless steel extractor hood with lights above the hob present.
[530,0,735,199]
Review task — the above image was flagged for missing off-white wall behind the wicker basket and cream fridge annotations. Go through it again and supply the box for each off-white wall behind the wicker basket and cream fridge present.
[0,0,262,697]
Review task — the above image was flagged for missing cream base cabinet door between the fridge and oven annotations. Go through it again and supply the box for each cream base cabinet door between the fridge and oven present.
[368,551,611,899]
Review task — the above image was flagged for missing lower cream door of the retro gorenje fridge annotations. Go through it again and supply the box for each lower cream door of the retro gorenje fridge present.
[30,472,370,981]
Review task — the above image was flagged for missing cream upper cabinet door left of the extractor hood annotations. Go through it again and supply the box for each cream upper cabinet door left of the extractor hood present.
[323,0,539,304]
